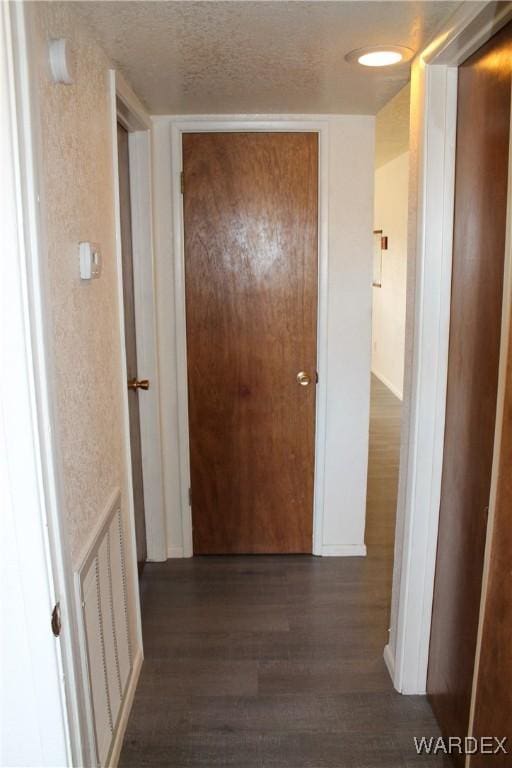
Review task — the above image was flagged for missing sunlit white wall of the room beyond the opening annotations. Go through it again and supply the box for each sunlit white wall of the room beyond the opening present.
[372,152,409,399]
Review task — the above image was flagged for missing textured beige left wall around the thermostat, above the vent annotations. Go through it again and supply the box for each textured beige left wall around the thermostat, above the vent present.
[30,3,125,564]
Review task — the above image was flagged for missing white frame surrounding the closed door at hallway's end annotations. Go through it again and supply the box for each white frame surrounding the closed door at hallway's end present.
[167,115,329,557]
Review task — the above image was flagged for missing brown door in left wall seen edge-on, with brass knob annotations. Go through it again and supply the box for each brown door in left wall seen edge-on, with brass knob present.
[117,124,147,574]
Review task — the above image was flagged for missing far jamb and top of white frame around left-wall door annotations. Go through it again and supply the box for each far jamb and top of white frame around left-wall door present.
[110,70,167,561]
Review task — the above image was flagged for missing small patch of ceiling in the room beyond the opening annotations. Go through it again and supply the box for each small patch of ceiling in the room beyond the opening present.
[375,84,411,168]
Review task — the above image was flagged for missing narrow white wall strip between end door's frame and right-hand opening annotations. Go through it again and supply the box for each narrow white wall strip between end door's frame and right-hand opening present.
[323,116,374,554]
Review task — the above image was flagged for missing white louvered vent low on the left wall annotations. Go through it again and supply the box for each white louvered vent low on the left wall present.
[76,494,132,766]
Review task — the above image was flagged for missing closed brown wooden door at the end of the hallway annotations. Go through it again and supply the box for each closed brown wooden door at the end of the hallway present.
[183,133,318,554]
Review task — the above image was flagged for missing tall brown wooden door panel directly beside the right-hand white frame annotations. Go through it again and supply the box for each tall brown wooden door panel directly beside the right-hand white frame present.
[427,26,512,752]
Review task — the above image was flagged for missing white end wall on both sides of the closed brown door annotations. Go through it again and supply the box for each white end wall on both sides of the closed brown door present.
[154,115,375,556]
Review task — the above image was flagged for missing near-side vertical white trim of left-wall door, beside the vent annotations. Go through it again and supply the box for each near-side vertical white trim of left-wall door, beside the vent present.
[109,69,142,648]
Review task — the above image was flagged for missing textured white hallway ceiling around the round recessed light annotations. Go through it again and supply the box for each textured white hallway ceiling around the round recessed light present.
[75,0,460,114]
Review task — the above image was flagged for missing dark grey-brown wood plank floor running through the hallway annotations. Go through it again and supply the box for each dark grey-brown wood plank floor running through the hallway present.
[120,379,443,768]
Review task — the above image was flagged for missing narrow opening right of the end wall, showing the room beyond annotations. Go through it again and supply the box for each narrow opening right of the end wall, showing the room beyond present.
[365,84,410,656]
